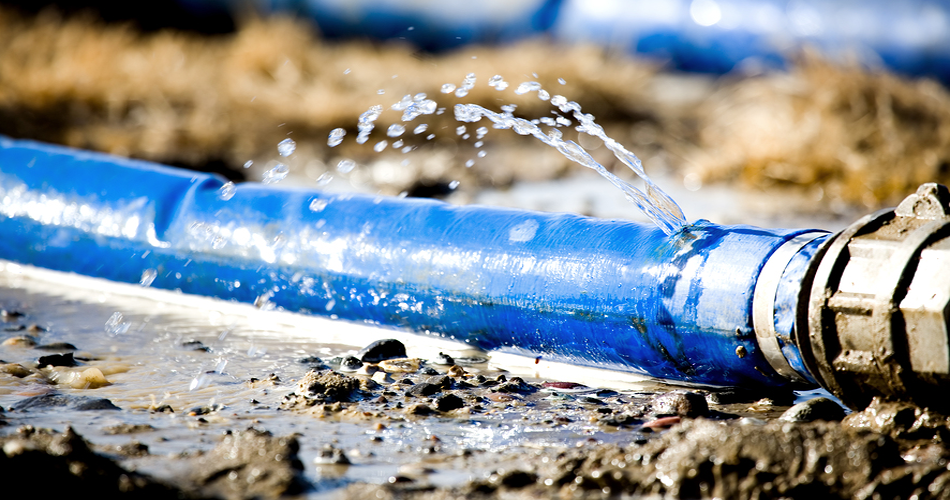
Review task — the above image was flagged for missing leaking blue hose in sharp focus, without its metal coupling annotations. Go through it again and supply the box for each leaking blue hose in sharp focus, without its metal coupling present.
[0,137,827,387]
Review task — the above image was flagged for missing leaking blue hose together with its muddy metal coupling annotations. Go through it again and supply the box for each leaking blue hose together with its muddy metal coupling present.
[0,138,950,411]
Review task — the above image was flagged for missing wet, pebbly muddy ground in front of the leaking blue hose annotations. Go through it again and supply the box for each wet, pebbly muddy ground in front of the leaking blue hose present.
[0,282,950,499]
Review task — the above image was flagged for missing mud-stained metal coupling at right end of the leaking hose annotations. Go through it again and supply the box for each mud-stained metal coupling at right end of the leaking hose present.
[795,183,950,412]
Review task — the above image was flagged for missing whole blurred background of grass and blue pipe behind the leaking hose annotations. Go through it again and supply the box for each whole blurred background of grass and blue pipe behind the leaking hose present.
[0,0,950,229]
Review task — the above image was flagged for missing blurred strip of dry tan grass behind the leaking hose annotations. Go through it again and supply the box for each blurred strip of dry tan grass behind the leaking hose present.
[0,5,950,207]
